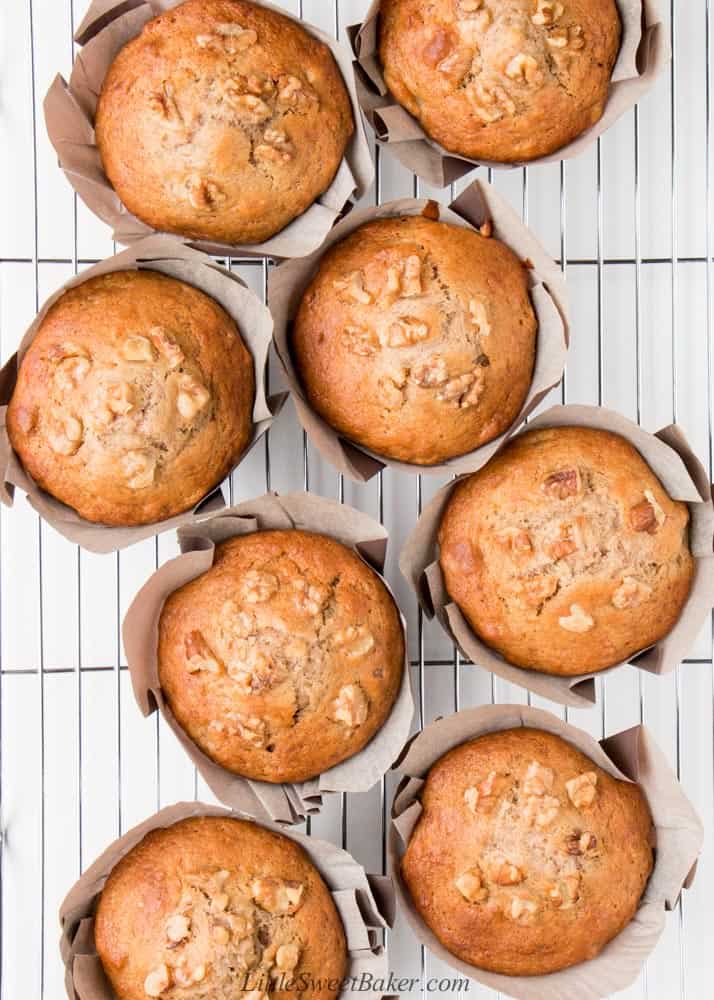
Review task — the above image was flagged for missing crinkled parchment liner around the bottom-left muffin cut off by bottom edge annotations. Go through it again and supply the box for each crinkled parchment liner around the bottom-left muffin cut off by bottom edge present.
[60,802,395,1000]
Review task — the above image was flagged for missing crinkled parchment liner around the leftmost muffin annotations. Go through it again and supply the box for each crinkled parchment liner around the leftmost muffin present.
[0,236,286,552]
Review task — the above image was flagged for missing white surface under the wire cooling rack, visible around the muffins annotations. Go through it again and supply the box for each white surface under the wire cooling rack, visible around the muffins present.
[0,0,714,1000]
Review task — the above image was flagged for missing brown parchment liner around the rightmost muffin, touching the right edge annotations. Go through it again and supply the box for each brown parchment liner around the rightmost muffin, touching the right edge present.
[399,406,714,708]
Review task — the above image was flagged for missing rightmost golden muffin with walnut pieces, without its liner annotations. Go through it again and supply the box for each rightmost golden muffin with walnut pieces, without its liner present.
[439,427,694,675]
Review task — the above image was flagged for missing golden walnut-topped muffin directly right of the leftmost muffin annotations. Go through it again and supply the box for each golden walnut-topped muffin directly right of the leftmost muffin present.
[292,217,537,465]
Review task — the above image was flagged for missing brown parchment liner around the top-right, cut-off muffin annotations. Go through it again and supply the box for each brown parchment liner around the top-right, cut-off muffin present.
[347,0,671,187]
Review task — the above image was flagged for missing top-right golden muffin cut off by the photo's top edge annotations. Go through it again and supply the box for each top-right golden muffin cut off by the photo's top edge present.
[380,0,620,163]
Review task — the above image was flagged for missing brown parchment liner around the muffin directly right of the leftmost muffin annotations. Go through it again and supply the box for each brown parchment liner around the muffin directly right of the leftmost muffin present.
[268,181,569,482]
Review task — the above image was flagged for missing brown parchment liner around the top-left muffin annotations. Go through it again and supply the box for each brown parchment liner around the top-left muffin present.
[44,0,374,257]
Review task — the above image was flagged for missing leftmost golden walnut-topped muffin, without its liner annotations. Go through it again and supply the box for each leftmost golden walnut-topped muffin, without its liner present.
[7,271,255,525]
